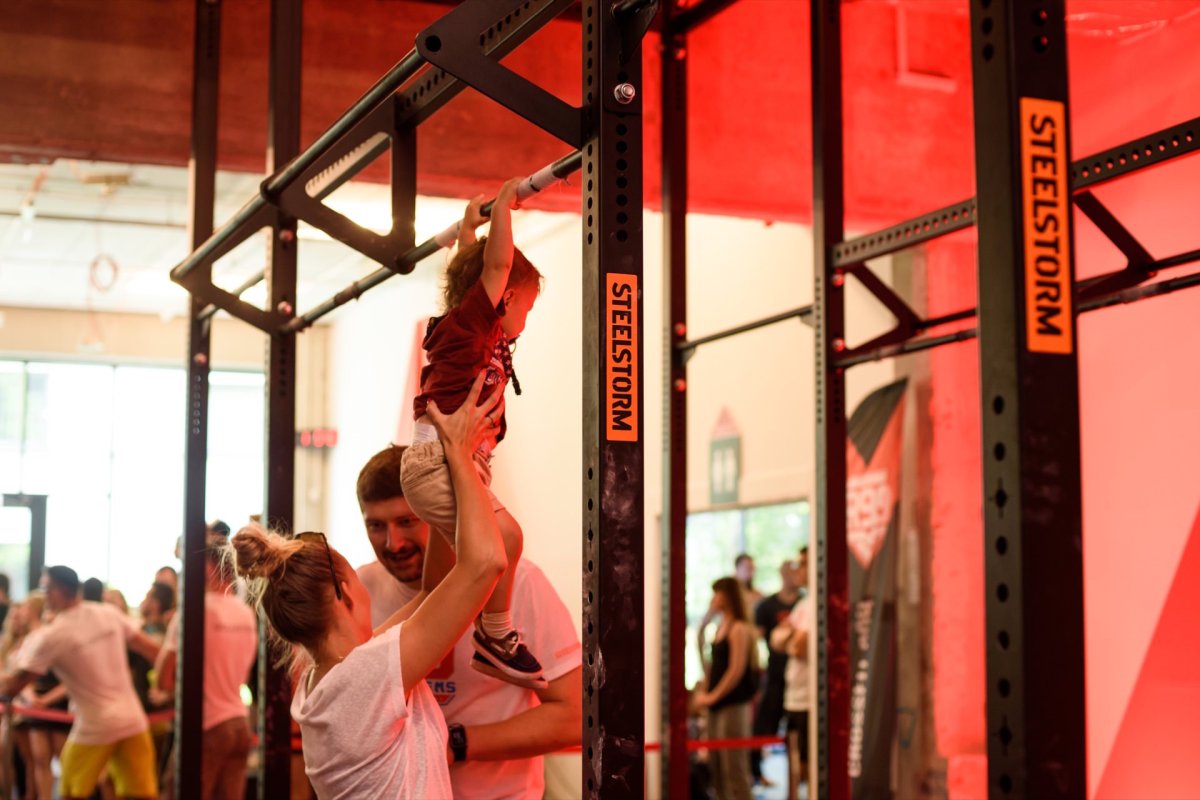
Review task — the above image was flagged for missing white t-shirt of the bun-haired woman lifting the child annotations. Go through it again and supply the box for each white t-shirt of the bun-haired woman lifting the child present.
[292,625,452,800]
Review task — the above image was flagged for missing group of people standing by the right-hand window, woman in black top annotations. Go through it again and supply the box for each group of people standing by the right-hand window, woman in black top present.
[691,547,812,800]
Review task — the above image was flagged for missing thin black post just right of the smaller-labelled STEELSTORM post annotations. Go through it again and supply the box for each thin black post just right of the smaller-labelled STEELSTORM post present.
[661,0,690,798]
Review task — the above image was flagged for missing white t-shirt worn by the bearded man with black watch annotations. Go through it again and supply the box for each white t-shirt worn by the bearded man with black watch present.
[368,559,583,800]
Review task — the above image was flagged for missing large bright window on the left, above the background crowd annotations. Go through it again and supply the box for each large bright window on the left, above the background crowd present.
[0,361,264,606]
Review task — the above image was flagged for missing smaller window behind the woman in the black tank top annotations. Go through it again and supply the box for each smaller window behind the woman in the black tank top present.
[684,500,811,687]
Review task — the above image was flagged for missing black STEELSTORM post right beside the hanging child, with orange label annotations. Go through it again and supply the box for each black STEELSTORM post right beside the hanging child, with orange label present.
[581,0,646,798]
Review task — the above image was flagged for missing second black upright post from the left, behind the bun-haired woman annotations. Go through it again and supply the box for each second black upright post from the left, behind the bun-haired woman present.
[258,0,302,800]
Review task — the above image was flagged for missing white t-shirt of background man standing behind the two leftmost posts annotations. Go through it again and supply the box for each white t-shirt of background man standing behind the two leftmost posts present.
[162,591,258,730]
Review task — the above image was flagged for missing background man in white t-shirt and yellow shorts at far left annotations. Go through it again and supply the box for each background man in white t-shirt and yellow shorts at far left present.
[0,566,158,798]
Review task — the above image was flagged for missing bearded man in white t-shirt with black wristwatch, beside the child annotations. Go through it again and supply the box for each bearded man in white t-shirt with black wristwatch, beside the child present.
[358,455,583,800]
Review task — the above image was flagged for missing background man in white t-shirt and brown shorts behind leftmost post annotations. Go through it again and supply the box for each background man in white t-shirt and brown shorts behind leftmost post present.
[155,534,258,800]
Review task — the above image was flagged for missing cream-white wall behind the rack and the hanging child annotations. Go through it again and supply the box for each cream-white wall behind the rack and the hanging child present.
[328,212,894,794]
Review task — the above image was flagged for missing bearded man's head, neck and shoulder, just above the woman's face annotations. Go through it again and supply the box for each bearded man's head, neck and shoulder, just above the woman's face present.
[355,445,430,627]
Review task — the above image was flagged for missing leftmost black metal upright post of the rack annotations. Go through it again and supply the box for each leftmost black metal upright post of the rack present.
[173,0,221,800]
